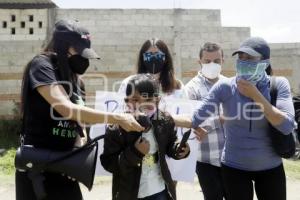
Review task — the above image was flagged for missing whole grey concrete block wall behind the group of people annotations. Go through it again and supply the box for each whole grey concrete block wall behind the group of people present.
[0,8,300,117]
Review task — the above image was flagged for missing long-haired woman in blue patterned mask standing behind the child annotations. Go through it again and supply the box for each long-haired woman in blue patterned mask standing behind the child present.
[118,38,186,98]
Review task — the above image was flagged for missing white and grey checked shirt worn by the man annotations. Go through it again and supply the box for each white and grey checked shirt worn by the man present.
[185,72,226,167]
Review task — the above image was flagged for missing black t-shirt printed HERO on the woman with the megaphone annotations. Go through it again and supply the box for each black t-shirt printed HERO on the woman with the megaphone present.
[23,55,83,150]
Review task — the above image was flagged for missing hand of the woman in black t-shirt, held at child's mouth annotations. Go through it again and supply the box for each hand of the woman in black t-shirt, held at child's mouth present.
[116,114,145,132]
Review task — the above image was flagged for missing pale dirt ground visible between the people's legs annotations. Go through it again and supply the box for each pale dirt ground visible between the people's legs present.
[0,177,300,200]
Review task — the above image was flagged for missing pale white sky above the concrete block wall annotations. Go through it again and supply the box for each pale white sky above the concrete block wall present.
[52,0,300,43]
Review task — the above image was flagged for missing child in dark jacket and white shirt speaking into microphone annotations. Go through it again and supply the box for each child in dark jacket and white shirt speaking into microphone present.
[100,74,190,200]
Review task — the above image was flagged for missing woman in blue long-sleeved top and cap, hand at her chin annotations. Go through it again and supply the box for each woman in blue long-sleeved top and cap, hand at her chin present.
[175,37,294,200]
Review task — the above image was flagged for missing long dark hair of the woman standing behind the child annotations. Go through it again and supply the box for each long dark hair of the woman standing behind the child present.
[137,38,180,93]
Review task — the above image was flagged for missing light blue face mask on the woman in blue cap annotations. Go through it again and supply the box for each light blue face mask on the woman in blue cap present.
[236,59,270,85]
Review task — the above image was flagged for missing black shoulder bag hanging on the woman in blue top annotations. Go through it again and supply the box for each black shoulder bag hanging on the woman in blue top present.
[269,77,296,158]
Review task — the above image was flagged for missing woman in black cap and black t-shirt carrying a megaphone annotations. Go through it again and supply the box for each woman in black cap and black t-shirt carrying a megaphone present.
[16,20,143,200]
